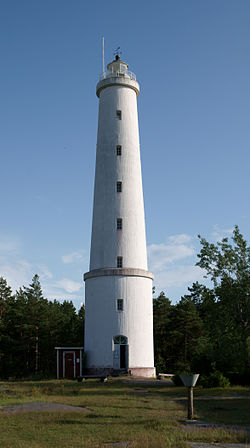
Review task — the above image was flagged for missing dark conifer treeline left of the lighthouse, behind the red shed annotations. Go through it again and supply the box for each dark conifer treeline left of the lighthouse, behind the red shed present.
[0,275,84,378]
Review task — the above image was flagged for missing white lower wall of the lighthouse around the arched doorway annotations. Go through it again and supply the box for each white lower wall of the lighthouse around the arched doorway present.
[84,276,154,368]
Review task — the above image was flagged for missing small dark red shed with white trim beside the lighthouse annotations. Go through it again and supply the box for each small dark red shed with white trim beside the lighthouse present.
[55,347,83,379]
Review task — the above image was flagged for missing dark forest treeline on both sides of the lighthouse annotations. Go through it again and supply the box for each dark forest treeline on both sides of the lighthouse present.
[0,226,250,383]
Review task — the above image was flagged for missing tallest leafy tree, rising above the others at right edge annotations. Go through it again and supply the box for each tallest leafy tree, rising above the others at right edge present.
[197,226,250,372]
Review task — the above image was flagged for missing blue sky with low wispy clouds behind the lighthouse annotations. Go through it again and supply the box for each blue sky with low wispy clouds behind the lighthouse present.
[0,0,250,308]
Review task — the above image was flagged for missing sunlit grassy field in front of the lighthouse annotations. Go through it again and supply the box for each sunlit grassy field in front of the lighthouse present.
[0,379,250,448]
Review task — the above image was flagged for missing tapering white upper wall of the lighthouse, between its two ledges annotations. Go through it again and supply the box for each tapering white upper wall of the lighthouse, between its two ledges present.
[90,82,147,270]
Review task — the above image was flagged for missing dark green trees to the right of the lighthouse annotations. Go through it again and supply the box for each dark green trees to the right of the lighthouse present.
[154,226,250,383]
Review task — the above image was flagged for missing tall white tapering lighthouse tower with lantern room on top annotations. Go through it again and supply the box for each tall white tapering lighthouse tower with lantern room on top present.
[84,55,155,377]
